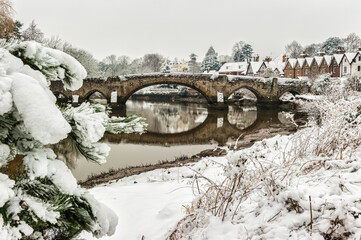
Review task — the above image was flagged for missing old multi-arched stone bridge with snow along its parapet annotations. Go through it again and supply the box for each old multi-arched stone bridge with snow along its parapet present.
[50,73,309,106]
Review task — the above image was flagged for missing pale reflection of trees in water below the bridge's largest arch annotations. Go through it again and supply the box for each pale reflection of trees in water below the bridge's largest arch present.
[126,100,208,133]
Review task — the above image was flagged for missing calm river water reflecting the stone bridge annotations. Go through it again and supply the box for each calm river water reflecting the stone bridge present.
[68,100,300,181]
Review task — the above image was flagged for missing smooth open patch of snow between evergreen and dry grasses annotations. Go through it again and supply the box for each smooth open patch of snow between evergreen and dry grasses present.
[79,157,227,240]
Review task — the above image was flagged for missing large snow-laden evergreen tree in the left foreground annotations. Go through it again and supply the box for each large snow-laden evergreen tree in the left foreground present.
[0,40,144,240]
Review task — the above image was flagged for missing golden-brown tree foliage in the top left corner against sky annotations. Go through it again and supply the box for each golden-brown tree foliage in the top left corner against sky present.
[0,0,16,38]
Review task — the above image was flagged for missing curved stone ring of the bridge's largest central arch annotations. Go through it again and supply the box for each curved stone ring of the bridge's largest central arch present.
[121,79,212,103]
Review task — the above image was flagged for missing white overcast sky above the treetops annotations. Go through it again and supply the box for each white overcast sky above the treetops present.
[14,0,361,60]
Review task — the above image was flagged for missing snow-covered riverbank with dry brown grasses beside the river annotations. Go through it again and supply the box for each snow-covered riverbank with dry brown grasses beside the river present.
[80,89,361,239]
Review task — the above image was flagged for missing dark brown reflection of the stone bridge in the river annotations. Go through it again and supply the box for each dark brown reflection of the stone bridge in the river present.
[102,110,281,146]
